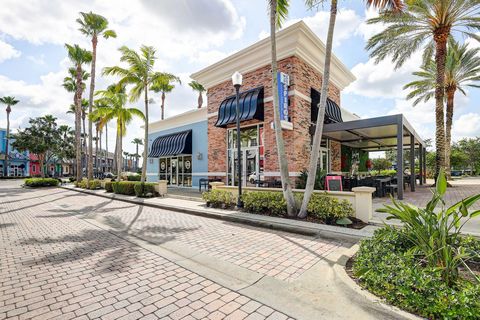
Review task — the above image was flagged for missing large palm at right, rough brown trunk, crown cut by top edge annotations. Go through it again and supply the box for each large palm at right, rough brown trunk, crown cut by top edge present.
[367,0,480,177]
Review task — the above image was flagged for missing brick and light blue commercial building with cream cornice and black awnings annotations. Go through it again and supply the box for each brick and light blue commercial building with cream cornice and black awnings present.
[147,22,424,199]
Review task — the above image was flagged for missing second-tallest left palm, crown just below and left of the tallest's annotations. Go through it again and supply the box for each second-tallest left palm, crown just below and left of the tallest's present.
[65,44,92,181]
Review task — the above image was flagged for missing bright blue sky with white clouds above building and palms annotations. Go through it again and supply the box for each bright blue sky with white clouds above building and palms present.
[0,0,480,152]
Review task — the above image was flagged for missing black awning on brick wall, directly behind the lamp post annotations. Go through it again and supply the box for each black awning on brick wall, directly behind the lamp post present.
[215,87,263,127]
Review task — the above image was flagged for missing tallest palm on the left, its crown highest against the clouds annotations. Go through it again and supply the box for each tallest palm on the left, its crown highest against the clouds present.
[77,11,117,179]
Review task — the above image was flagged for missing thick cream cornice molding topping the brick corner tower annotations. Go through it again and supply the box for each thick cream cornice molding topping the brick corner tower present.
[190,21,355,90]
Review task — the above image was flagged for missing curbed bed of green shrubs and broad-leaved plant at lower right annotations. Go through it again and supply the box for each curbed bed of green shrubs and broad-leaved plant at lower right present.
[346,174,480,319]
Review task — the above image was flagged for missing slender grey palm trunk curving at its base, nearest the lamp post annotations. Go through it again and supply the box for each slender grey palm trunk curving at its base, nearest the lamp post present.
[270,0,296,217]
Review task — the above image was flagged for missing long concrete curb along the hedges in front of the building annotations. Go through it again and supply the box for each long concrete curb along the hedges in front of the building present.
[60,186,378,243]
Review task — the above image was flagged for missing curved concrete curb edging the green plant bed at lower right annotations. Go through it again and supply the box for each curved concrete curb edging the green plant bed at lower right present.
[333,244,424,320]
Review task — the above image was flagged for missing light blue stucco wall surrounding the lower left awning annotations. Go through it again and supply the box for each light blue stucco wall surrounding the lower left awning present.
[147,120,208,188]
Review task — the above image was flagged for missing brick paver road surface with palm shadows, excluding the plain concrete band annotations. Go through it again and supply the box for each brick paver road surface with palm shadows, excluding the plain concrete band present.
[0,181,339,319]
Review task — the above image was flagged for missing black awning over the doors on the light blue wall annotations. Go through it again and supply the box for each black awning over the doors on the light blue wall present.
[148,130,192,158]
